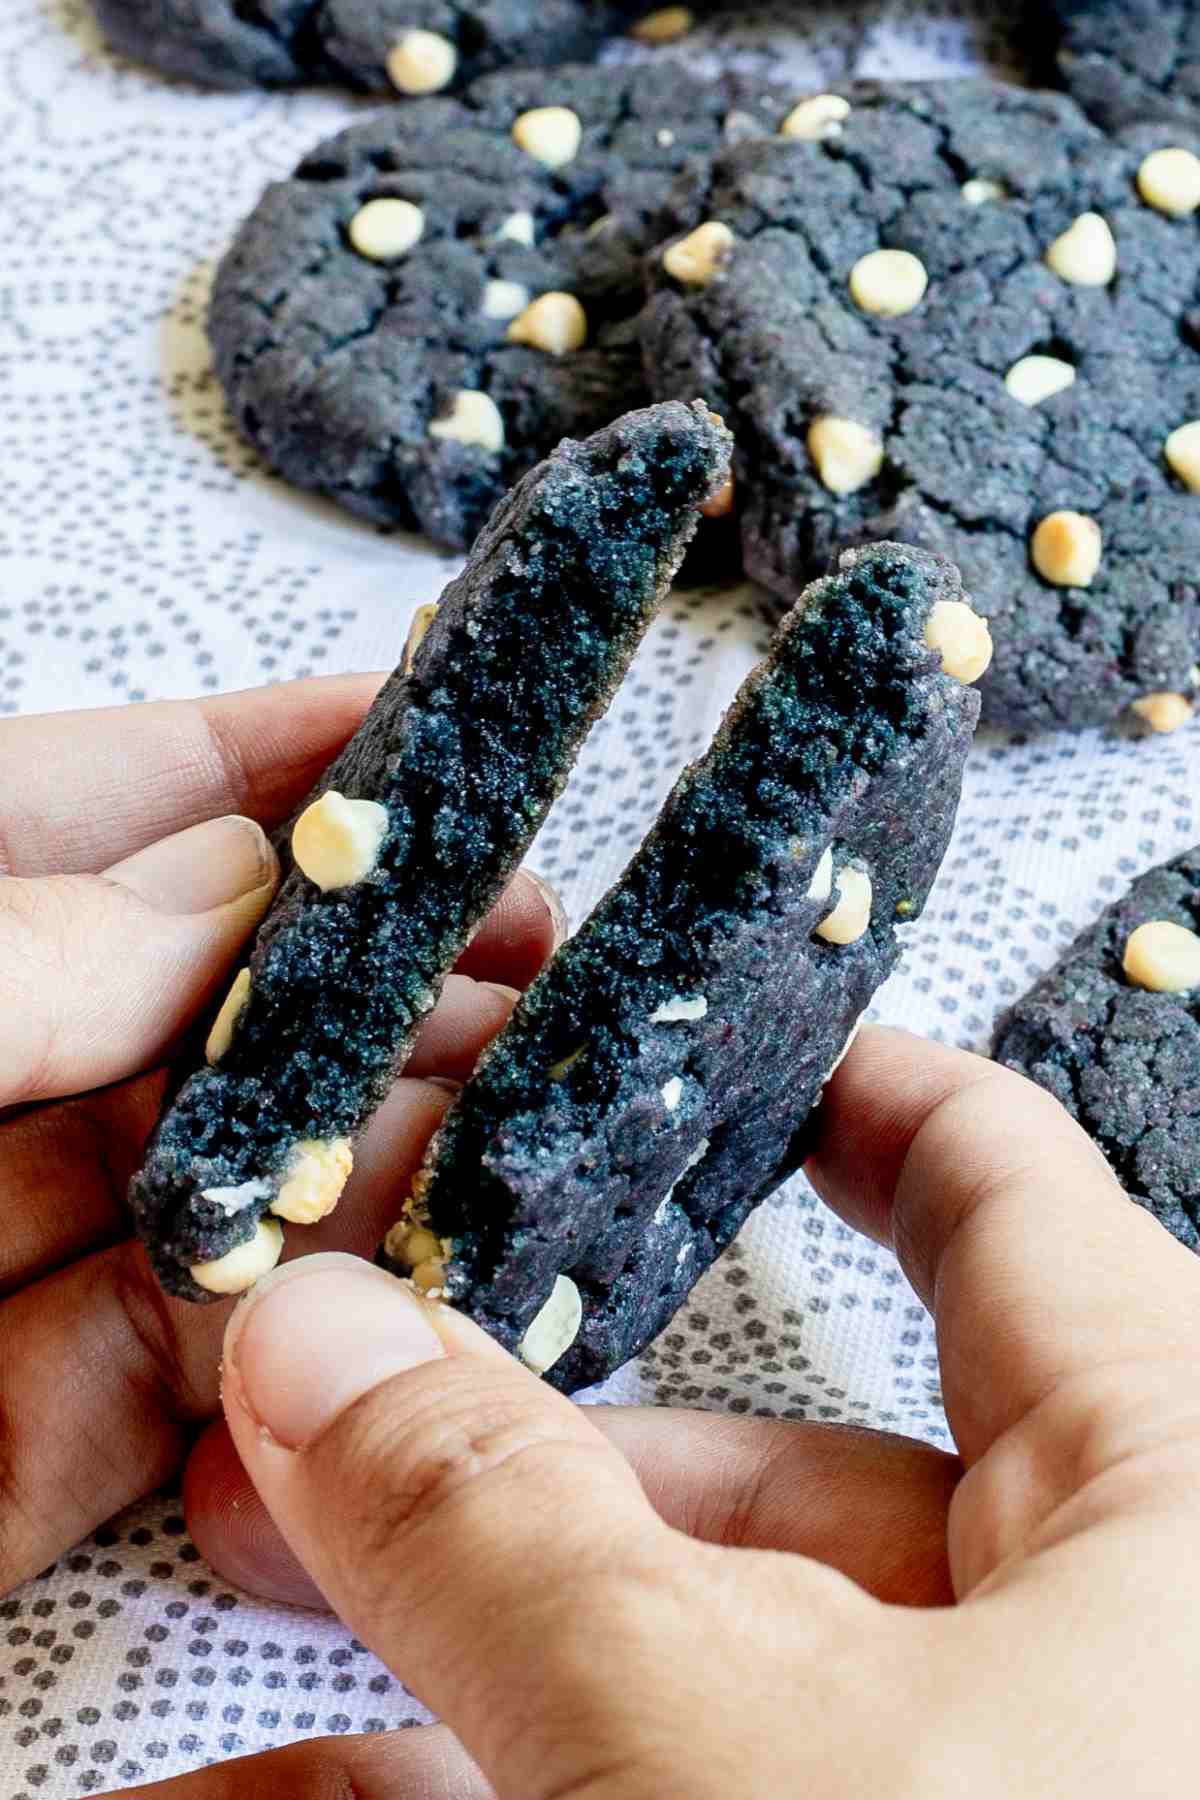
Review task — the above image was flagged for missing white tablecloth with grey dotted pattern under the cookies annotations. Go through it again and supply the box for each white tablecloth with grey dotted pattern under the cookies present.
[0,0,1200,1800]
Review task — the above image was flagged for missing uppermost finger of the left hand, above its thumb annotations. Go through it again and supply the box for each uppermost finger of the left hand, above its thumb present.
[0,675,380,875]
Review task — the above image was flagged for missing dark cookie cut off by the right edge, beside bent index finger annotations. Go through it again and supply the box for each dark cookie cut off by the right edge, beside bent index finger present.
[993,848,1200,1249]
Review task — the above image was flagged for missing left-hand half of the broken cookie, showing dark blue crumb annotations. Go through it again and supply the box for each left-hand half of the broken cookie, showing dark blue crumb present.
[131,403,729,1300]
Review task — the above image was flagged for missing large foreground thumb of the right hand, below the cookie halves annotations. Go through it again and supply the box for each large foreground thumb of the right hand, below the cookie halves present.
[223,1255,694,1800]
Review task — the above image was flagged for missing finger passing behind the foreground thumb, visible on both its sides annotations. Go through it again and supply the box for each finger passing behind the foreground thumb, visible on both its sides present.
[184,1406,963,1606]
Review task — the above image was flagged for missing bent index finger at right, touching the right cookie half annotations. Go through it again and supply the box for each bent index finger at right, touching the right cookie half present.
[808,1030,1200,1463]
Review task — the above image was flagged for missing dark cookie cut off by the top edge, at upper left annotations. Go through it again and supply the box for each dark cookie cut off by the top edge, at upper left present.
[94,0,649,94]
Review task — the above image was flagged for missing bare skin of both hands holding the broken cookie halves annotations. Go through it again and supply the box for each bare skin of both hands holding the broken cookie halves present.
[0,680,1200,1800]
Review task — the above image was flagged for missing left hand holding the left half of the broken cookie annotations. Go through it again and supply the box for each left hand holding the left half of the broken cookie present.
[0,677,554,1589]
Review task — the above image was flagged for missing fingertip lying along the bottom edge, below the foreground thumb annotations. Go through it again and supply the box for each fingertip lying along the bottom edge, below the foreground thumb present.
[111,1724,493,1800]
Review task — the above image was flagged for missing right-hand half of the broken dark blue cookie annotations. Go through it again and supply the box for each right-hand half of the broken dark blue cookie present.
[383,545,979,1390]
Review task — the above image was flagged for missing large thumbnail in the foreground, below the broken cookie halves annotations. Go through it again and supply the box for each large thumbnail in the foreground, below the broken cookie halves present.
[225,1251,444,1449]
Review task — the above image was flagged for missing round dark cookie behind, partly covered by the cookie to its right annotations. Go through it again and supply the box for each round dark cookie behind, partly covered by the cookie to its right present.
[210,68,779,547]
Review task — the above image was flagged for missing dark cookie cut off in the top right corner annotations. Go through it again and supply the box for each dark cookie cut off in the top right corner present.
[1051,0,1200,130]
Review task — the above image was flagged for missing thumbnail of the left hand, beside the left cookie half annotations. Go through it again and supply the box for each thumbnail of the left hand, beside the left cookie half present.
[104,814,279,913]
